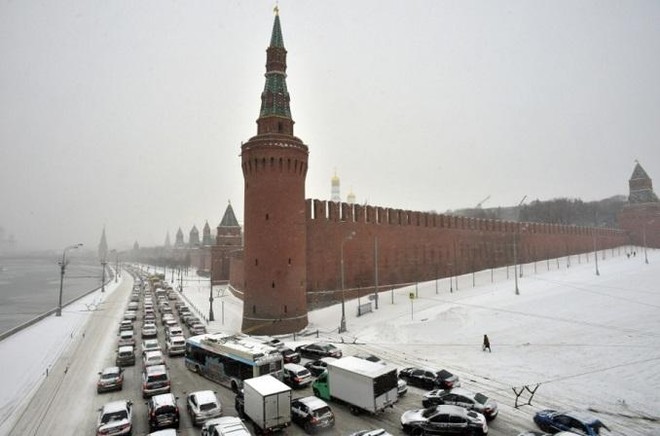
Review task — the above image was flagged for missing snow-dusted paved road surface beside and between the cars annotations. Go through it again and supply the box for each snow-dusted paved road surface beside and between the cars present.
[11,274,533,436]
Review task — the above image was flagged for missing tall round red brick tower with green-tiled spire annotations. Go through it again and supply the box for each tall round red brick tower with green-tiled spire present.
[241,9,309,334]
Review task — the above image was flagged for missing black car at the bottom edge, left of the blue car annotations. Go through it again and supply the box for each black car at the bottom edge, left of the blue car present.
[401,406,488,436]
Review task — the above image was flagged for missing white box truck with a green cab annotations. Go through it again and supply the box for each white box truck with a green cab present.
[312,356,398,414]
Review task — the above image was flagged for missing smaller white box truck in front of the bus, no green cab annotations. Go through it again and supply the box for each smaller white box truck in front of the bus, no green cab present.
[243,375,291,434]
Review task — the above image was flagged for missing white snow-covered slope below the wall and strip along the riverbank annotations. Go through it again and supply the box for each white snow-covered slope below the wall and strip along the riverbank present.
[0,248,660,435]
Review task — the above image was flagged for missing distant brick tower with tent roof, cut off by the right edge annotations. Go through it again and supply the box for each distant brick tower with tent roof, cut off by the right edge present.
[619,161,660,248]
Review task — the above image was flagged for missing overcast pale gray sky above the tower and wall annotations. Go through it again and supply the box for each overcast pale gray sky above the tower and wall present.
[0,0,660,248]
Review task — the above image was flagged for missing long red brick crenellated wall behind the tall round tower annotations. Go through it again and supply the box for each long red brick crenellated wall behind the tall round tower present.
[230,199,630,307]
